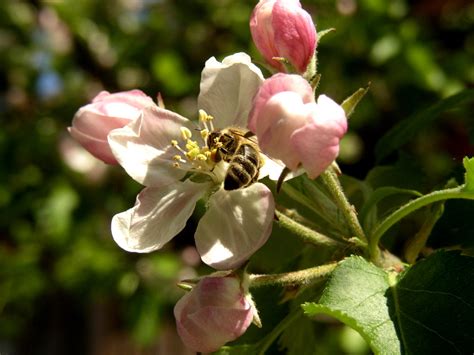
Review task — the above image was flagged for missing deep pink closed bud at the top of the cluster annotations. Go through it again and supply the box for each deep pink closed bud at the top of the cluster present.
[250,0,317,73]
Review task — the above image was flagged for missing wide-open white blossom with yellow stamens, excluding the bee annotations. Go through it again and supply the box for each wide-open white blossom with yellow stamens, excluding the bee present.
[109,53,281,269]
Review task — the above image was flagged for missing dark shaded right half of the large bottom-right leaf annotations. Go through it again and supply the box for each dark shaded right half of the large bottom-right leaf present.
[388,251,474,354]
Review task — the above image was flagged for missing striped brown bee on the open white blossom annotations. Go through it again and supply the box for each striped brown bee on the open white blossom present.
[207,127,263,190]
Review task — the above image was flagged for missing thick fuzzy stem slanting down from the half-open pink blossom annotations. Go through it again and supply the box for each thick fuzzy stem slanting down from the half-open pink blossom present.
[321,168,367,242]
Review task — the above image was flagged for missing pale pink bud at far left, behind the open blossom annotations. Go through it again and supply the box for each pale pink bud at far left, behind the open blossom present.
[68,90,155,164]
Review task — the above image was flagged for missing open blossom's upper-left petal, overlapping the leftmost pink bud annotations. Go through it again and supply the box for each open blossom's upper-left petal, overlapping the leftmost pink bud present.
[109,107,195,186]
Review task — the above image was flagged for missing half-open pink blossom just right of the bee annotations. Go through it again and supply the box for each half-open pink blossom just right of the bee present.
[249,73,347,178]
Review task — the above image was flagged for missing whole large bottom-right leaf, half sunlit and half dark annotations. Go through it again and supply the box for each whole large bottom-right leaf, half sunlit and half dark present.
[303,251,474,354]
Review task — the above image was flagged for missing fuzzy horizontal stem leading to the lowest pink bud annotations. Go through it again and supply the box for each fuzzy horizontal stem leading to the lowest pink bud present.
[249,263,337,287]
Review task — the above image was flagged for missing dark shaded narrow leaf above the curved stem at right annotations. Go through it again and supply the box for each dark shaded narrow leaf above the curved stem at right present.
[375,89,474,162]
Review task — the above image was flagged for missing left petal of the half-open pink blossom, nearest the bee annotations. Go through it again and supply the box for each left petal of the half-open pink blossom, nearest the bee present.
[257,91,315,170]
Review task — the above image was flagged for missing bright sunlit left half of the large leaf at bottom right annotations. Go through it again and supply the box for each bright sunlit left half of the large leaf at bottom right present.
[303,256,401,354]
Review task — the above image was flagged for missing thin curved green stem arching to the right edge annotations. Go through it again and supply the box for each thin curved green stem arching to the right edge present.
[369,185,474,261]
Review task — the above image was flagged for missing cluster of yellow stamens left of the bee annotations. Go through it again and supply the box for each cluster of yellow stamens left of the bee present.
[171,110,221,179]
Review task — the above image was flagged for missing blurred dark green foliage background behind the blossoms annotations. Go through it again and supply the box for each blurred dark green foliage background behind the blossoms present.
[0,0,474,355]
